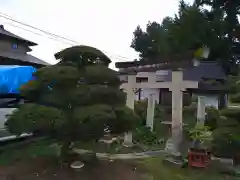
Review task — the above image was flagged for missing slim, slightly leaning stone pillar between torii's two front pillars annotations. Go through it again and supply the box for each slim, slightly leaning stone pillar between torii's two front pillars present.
[146,94,155,131]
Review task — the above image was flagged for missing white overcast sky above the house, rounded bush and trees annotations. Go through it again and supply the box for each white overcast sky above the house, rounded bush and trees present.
[0,0,191,68]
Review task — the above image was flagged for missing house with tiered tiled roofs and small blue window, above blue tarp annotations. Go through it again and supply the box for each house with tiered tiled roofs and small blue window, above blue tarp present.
[0,25,50,68]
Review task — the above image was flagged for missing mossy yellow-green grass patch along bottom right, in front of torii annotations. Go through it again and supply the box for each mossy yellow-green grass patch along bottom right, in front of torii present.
[140,158,237,180]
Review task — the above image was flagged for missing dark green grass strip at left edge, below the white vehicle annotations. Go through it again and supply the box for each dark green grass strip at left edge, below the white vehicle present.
[0,139,57,165]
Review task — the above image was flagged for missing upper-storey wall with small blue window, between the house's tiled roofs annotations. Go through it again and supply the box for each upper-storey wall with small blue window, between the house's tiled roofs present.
[0,40,29,54]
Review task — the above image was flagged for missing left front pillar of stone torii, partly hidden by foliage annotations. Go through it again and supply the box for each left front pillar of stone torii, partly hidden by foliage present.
[123,75,136,147]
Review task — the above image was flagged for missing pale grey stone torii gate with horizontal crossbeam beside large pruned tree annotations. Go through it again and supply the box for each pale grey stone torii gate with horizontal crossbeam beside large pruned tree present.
[121,71,198,152]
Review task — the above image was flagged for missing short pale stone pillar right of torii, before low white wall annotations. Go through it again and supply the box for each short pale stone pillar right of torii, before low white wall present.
[197,96,206,124]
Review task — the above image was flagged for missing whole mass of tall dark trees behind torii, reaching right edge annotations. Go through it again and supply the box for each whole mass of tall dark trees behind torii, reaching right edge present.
[131,0,240,74]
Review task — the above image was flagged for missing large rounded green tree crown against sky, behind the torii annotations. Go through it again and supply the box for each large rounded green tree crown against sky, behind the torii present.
[131,1,213,61]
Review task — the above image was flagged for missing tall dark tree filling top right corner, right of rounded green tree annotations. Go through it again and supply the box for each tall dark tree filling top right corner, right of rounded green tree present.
[195,0,240,74]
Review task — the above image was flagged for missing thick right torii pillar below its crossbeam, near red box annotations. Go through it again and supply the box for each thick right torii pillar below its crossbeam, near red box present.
[172,88,183,153]
